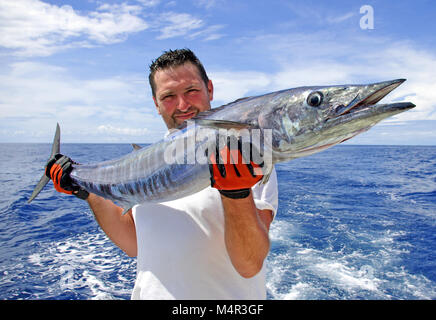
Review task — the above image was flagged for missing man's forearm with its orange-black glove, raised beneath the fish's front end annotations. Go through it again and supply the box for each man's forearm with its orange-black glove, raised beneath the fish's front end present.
[209,137,273,278]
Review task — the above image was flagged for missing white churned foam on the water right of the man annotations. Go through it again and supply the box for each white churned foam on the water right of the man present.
[267,215,436,300]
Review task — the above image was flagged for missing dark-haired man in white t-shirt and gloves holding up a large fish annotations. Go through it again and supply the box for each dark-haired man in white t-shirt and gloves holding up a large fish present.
[46,49,277,299]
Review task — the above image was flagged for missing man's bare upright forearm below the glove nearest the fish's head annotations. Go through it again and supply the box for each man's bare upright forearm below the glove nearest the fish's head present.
[221,194,273,278]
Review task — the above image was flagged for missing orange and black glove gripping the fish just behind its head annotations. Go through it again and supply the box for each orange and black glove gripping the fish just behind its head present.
[208,137,263,199]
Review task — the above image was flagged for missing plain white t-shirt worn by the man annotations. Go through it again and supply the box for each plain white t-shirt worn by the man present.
[131,170,278,299]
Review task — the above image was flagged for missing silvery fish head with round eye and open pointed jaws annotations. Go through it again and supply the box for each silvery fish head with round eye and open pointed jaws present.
[271,79,415,161]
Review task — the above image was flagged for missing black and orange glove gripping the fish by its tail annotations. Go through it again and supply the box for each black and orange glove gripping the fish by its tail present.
[45,153,89,200]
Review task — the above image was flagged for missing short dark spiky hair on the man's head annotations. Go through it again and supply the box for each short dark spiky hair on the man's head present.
[148,48,209,97]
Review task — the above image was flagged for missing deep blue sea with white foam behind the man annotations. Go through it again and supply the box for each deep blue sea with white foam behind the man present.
[0,144,436,300]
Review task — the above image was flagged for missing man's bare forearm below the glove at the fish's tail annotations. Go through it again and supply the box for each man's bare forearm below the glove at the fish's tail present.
[87,193,137,257]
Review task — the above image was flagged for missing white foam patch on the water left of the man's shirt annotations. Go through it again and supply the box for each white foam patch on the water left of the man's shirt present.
[28,232,136,299]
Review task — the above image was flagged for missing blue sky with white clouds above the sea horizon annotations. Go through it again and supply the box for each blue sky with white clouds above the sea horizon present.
[0,0,436,145]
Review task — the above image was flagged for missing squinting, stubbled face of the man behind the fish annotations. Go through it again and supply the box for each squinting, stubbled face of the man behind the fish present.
[153,62,213,129]
